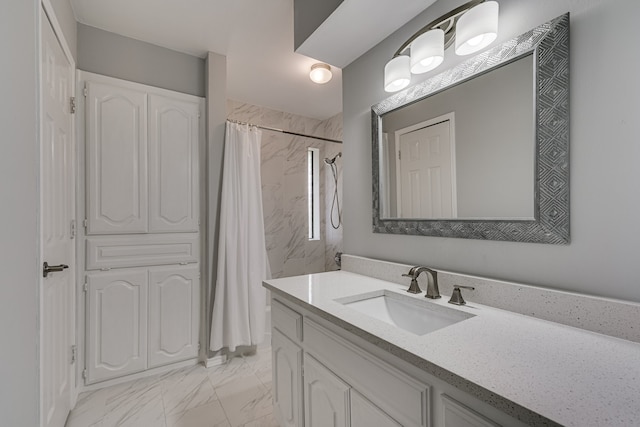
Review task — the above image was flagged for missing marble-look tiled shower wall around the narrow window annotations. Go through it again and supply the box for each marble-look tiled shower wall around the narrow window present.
[227,100,342,278]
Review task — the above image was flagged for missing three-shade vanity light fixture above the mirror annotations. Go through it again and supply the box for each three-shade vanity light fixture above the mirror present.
[384,0,499,92]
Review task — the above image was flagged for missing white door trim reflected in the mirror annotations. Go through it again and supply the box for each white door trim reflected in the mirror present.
[394,111,458,218]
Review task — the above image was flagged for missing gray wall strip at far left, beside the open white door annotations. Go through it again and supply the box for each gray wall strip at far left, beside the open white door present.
[0,0,40,427]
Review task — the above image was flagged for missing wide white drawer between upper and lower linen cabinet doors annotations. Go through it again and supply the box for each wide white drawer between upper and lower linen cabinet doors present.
[86,233,200,270]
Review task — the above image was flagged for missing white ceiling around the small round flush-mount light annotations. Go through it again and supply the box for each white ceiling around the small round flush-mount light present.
[71,0,434,120]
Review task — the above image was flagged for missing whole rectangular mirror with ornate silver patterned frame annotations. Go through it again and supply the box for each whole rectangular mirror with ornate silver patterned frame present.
[371,14,569,244]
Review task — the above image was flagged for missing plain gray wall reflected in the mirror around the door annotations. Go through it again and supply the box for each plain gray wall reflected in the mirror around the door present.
[382,55,535,218]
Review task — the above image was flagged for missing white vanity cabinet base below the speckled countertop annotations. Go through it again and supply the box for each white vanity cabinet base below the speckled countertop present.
[271,294,525,427]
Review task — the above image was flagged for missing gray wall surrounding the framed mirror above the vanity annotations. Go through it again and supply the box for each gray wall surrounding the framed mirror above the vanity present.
[343,0,640,302]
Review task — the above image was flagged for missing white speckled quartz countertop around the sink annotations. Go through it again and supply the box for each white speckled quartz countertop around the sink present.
[264,271,640,427]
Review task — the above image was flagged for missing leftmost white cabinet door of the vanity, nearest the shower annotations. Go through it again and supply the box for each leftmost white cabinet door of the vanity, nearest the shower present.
[271,329,302,427]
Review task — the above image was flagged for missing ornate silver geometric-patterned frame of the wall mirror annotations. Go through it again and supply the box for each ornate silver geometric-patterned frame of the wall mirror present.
[371,13,569,244]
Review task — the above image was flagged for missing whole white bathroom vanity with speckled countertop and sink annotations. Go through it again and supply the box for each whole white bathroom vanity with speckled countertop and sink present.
[264,256,640,427]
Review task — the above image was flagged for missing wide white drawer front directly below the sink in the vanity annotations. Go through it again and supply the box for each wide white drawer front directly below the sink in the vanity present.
[304,318,431,427]
